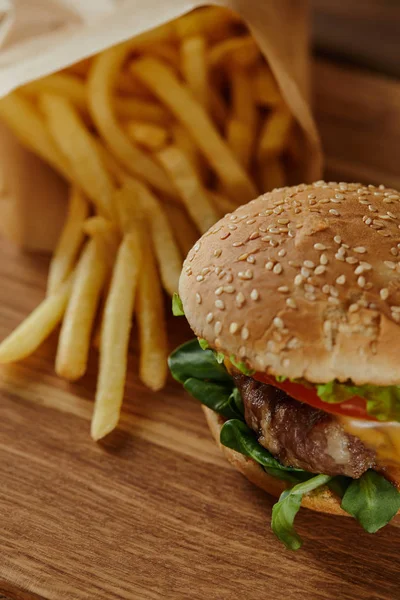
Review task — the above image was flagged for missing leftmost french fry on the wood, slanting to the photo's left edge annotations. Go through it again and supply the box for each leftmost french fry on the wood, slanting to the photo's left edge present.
[0,274,73,364]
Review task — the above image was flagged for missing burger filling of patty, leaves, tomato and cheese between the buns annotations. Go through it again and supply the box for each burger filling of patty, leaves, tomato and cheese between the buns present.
[169,340,400,549]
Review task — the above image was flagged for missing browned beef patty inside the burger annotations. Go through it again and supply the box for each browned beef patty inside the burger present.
[234,374,375,479]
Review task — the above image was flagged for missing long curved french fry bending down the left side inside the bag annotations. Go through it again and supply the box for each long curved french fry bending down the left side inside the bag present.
[88,43,175,195]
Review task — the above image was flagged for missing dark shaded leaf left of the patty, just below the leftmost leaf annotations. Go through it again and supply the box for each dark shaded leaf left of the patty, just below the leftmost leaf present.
[183,378,243,419]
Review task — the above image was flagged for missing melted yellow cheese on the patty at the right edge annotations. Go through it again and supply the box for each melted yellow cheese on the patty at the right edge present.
[338,416,400,467]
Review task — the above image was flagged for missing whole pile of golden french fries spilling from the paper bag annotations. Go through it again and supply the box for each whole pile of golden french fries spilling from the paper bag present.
[0,7,296,440]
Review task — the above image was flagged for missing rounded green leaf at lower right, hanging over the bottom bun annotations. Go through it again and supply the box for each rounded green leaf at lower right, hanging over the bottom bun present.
[341,469,400,533]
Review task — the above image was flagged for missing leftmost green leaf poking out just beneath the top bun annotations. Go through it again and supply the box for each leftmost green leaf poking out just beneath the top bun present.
[168,338,233,389]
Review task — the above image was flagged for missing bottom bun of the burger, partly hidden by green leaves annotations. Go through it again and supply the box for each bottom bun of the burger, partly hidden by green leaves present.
[202,406,400,527]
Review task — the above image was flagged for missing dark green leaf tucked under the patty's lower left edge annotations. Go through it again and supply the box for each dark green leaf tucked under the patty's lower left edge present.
[220,419,301,471]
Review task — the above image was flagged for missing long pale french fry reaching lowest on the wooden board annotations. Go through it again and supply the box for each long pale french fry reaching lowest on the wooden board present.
[91,232,142,440]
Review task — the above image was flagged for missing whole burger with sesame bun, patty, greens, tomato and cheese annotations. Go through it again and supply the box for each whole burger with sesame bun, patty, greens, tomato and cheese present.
[169,181,400,549]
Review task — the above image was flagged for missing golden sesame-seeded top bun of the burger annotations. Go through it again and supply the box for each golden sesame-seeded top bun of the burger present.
[179,181,400,386]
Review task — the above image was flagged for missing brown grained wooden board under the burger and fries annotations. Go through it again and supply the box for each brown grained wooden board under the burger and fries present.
[0,58,400,600]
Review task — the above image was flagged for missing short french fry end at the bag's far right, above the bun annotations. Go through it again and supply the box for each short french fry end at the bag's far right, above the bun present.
[257,106,293,163]
